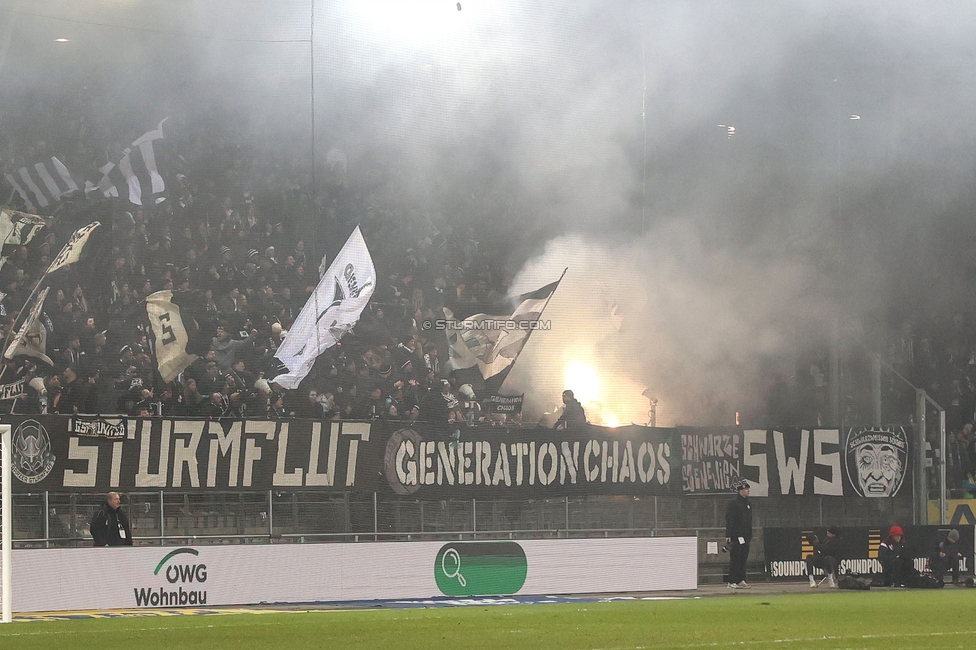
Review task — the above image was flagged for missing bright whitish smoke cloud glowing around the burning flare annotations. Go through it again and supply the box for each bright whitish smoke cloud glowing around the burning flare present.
[507,221,834,426]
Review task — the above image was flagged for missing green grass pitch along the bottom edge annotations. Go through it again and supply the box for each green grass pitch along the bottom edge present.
[0,589,976,650]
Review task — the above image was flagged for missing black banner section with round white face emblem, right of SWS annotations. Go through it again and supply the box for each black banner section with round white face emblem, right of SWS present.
[844,427,908,497]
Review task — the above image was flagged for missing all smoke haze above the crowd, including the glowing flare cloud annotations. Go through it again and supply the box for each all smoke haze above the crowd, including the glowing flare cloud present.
[0,0,976,424]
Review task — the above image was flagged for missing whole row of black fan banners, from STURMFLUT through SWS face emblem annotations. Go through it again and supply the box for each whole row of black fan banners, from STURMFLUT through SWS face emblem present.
[2,415,910,499]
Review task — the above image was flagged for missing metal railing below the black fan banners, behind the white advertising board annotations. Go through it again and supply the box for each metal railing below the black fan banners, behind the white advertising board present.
[7,490,913,548]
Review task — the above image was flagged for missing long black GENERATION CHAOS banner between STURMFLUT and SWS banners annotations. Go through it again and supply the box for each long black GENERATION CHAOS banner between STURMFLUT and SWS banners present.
[383,426,680,499]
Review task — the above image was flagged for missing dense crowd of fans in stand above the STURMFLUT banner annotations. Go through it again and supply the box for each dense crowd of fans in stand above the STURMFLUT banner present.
[0,124,532,426]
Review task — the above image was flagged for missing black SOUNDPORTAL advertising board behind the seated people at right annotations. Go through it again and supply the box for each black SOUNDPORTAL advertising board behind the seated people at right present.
[763,525,974,578]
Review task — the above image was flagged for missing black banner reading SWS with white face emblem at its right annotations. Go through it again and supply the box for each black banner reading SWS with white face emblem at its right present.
[676,427,910,498]
